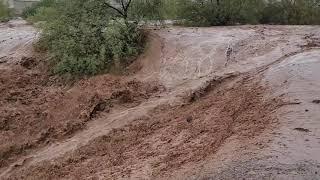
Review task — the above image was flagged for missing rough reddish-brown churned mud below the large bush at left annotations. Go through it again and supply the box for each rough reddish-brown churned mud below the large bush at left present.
[0,62,163,167]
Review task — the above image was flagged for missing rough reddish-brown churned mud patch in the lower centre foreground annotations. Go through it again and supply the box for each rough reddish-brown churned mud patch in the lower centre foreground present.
[7,75,281,179]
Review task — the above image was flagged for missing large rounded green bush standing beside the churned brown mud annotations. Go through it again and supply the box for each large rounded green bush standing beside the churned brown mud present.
[33,0,143,76]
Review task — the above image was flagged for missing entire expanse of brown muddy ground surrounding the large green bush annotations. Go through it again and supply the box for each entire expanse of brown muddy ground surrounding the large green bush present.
[0,22,320,179]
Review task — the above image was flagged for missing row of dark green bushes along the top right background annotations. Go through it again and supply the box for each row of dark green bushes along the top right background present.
[176,0,320,26]
